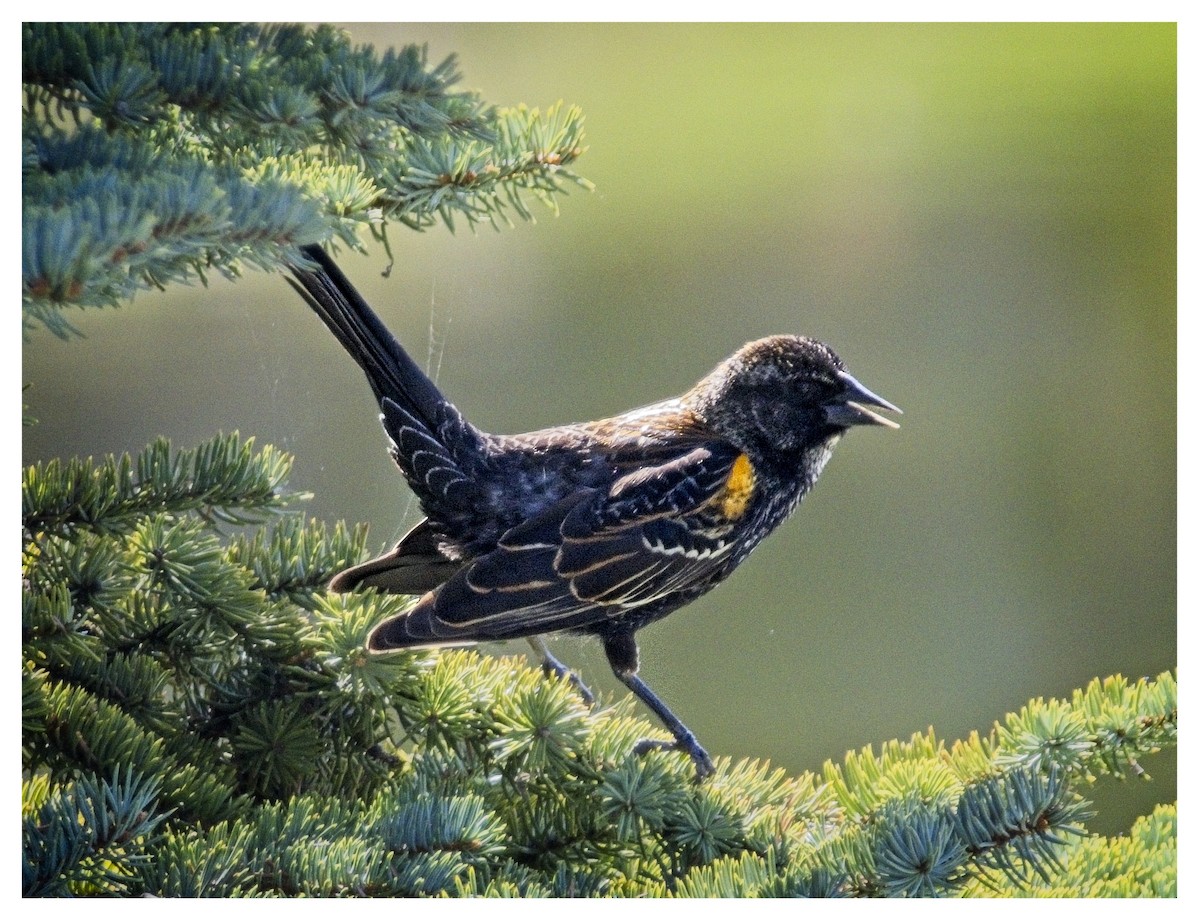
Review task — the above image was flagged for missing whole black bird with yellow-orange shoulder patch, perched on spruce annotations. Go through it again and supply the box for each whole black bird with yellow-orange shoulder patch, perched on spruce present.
[289,246,900,777]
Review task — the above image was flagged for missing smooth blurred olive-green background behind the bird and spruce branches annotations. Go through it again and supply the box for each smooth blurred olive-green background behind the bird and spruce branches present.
[23,24,1176,832]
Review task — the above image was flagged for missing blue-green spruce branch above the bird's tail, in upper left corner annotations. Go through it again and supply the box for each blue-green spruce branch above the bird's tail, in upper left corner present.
[22,23,588,336]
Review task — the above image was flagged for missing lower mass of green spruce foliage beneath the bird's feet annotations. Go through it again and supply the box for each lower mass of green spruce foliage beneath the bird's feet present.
[16,435,1177,897]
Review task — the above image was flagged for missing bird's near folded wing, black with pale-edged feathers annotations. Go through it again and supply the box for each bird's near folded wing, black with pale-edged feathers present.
[370,441,745,650]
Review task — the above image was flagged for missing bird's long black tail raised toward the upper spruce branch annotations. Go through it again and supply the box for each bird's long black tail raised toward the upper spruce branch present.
[288,246,486,510]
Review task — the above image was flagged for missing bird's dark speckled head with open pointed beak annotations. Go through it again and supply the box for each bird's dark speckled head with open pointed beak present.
[690,336,900,463]
